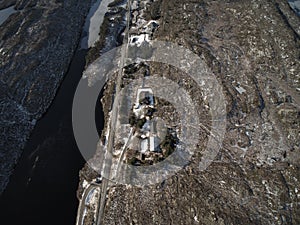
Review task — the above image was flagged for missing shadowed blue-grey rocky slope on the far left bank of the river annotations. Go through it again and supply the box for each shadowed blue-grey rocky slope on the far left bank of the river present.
[0,0,91,193]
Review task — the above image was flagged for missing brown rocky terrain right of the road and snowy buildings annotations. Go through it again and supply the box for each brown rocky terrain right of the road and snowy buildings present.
[79,0,300,225]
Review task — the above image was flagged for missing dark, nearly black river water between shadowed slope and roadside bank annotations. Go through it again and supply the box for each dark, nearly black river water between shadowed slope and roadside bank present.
[0,50,103,225]
